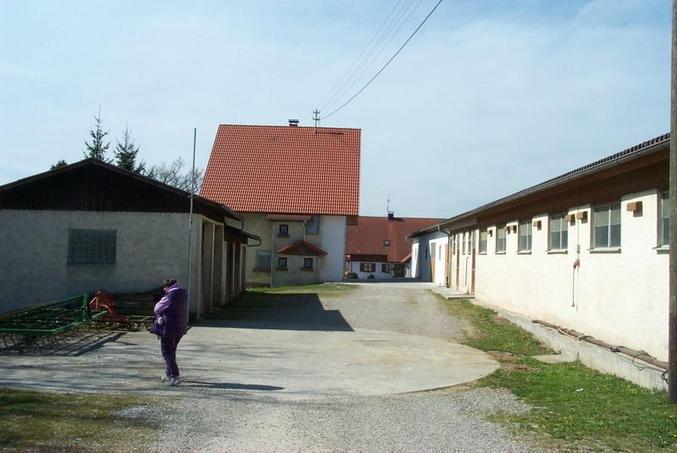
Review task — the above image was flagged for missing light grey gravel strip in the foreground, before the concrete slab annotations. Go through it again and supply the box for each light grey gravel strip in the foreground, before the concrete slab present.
[153,388,534,452]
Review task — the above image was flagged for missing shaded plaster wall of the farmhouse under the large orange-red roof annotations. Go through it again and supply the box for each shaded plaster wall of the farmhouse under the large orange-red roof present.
[243,213,346,286]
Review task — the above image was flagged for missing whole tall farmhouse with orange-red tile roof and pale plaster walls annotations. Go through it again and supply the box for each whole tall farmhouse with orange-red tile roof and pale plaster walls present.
[200,121,360,286]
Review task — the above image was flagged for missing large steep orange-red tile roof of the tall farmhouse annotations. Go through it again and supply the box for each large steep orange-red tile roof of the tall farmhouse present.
[200,124,360,215]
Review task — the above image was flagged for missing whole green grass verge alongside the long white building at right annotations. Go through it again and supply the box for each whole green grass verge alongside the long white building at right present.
[434,292,677,451]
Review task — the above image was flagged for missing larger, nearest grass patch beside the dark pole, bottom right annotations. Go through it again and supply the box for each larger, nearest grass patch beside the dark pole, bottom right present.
[480,359,677,451]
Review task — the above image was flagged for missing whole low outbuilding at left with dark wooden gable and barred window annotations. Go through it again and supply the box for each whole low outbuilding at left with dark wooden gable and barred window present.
[0,159,258,318]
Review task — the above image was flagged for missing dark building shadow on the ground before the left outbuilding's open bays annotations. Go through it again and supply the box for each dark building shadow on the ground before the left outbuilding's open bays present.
[200,291,353,332]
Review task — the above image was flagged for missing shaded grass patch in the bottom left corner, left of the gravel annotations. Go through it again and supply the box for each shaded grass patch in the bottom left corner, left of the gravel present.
[0,388,157,451]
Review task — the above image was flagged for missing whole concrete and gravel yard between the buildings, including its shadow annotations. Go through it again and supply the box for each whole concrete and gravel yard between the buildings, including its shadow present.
[0,284,540,451]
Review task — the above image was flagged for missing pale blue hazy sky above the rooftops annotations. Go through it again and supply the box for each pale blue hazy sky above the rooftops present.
[0,0,671,218]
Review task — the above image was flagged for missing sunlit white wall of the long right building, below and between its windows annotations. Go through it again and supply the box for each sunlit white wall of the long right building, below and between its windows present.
[472,192,669,360]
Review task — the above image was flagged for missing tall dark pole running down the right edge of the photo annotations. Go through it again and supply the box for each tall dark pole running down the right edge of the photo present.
[668,0,677,403]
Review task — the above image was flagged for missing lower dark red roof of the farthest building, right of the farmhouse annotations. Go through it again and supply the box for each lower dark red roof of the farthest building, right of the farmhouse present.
[346,216,442,263]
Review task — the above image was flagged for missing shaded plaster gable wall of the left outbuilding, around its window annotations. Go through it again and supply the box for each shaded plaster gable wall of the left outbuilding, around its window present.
[0,210,206,312]
